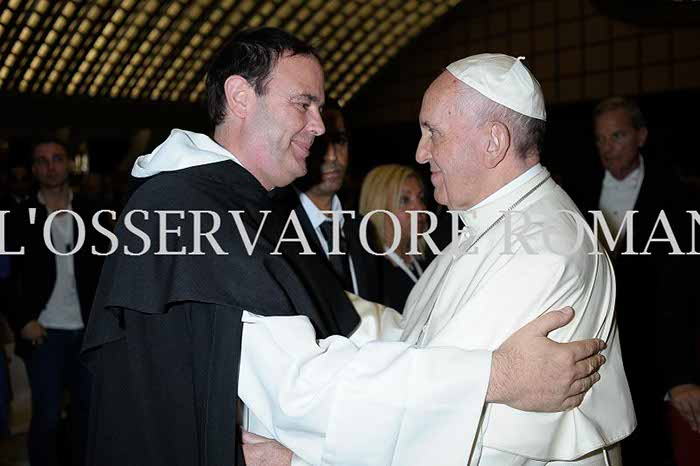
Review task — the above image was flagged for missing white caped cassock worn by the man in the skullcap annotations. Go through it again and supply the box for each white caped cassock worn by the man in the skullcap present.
[403,167,636,465]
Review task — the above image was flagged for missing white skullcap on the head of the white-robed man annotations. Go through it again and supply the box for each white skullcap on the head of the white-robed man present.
[447,53,547,121]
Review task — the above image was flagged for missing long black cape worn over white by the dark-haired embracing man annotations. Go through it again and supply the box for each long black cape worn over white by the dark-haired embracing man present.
[83,161,358,466]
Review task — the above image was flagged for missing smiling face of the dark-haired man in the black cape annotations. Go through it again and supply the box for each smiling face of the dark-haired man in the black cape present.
[250,55,325,188]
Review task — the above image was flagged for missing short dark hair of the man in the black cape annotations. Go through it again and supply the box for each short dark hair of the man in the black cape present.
[207,27,320,126]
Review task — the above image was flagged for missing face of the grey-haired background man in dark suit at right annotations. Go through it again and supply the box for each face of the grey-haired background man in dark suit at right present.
[595,109,647,180]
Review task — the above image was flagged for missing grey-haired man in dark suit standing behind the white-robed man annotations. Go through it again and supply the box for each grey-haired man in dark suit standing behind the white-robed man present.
[572,96,700,464]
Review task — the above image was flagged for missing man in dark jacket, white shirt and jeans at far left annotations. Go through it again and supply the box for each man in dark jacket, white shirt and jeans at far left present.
[8,139,105,466]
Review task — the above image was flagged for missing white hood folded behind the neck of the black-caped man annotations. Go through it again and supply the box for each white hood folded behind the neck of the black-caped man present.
[131,129,245,178]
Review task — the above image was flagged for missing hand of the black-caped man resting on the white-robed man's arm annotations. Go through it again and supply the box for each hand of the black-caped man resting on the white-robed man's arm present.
[486,307,606,412]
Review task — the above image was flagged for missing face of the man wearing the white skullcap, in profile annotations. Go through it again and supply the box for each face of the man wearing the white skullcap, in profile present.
[416,71,484,210]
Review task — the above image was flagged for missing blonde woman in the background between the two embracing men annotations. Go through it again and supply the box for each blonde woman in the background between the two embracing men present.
[360,164,428,312]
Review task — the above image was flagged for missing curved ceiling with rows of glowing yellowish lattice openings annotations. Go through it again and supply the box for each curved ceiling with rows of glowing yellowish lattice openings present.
[0,0,459,104]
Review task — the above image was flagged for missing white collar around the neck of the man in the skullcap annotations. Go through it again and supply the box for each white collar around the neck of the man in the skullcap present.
[459,163,551,234]
